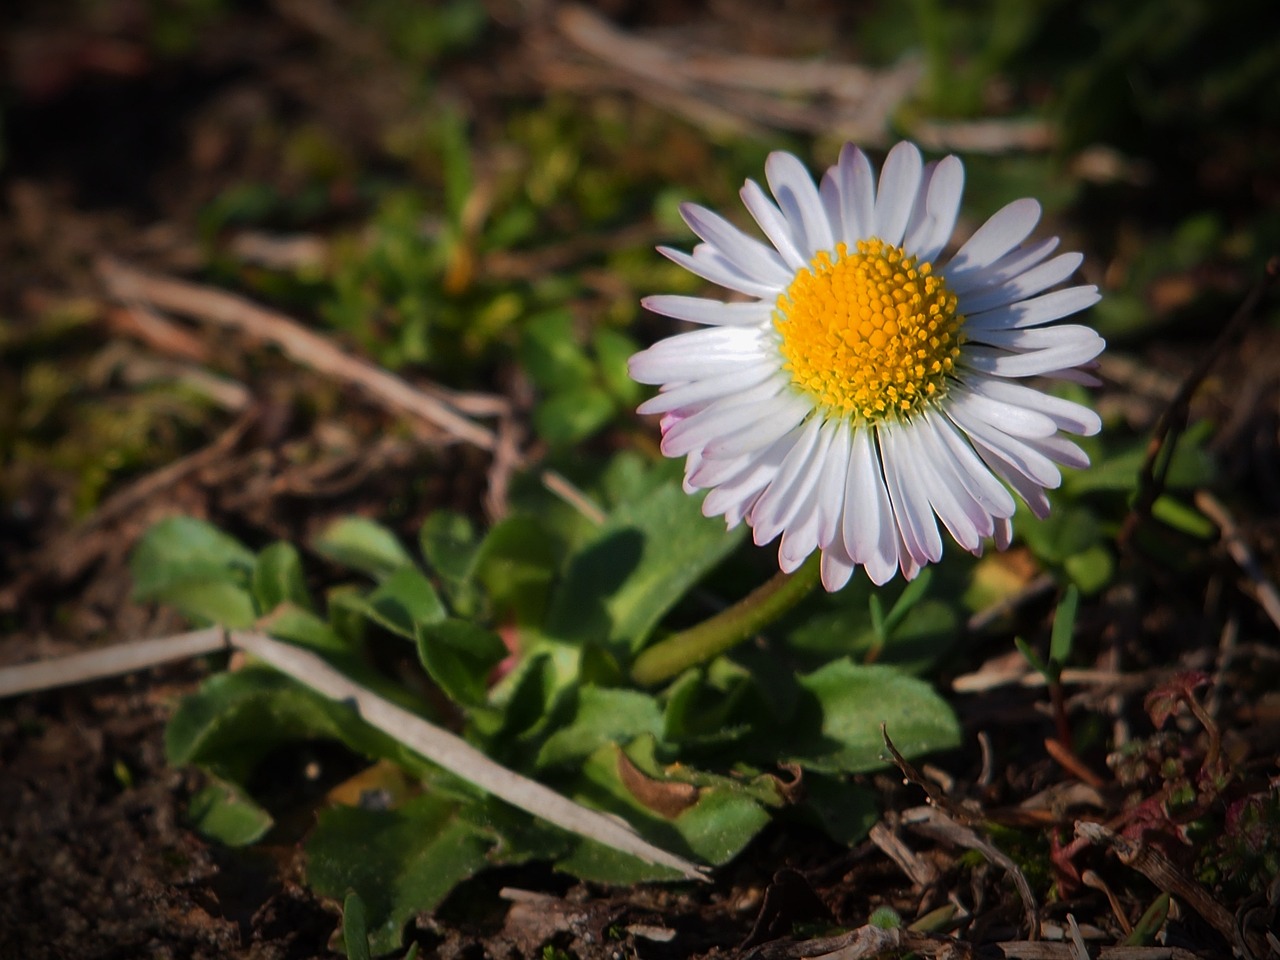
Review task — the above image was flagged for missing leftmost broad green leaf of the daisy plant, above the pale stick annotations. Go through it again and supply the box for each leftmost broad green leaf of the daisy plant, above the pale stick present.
[129,517,255,600]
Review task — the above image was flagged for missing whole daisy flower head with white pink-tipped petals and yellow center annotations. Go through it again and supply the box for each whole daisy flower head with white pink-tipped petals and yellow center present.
[630,143,1105,590]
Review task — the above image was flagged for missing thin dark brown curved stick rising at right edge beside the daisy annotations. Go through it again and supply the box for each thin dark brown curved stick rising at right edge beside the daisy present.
[1116,257,1280,549]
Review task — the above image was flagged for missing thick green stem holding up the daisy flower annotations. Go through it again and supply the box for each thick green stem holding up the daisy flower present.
[631,550,822,686]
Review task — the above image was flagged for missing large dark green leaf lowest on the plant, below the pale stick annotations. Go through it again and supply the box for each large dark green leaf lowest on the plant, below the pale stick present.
[306,795,489,954]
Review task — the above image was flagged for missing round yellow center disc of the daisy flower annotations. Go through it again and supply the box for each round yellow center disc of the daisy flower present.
[773,238,964,422]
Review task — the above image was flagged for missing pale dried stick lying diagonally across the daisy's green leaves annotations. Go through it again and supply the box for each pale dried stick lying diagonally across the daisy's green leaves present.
[228,630,707,881]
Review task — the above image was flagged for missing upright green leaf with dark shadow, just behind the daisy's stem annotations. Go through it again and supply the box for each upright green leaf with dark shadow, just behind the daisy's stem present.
[547,484,745,659]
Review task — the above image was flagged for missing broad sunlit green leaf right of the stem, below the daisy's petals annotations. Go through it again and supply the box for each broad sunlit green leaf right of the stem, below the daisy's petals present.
[764,659,960,773]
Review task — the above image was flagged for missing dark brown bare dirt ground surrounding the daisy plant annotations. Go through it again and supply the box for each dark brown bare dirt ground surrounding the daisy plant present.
[0,0,1280,960]
